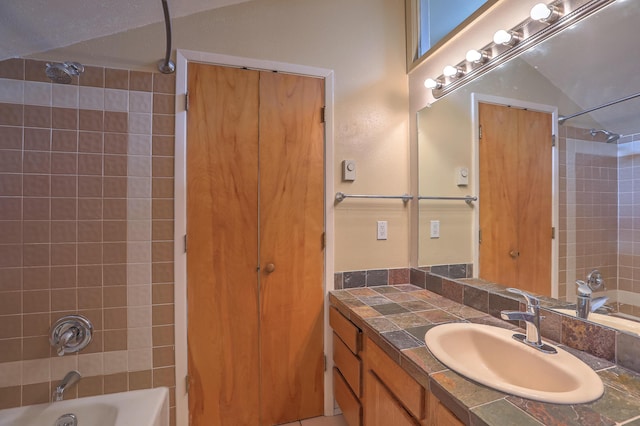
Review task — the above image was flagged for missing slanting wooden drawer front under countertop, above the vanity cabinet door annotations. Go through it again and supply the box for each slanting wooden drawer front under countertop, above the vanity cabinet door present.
[364,338,425,420]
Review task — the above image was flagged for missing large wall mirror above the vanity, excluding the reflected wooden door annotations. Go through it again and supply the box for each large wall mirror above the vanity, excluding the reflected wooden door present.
[418,0,640,326]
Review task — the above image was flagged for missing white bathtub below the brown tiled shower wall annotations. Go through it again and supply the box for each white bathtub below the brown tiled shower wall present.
[0,388,169,426]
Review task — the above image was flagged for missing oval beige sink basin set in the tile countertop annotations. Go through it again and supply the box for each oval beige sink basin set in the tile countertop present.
[425,323,604,404]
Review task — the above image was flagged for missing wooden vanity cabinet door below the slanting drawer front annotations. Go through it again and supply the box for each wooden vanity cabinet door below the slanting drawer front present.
[364,371,420,426]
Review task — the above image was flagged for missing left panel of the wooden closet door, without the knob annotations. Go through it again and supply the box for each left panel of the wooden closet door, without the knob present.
[187,63,260,426]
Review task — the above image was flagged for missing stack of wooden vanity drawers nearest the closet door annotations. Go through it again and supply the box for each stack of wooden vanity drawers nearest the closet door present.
[329,307,363,426]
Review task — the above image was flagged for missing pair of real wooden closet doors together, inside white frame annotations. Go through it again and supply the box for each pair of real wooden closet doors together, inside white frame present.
[187,60,324,426]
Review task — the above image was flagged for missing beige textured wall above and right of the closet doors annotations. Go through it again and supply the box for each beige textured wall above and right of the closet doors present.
[32,0,409,271]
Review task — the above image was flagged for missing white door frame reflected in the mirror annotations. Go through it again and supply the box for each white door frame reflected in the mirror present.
[471,92,560,298]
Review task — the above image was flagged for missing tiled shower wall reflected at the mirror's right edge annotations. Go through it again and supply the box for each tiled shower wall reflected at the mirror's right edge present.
[560,126,640,315]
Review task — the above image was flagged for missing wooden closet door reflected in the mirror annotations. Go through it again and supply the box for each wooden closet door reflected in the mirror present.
[479,103,553,296]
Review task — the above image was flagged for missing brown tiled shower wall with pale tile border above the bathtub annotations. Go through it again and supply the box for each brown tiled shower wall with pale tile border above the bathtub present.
[0,59,175,417]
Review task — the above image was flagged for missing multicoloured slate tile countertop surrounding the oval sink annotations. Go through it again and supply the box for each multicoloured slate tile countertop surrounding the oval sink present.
[329,284,640,426]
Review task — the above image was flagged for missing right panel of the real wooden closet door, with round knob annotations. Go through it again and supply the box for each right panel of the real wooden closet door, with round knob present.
[260,72,324,425]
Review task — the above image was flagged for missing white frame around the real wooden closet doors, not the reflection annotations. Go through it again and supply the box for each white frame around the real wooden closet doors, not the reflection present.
[174,49,335,426]
